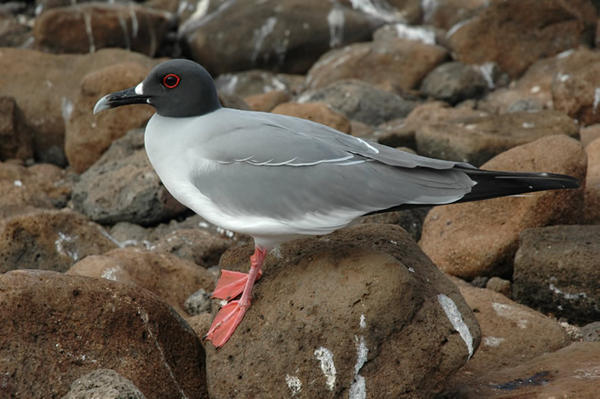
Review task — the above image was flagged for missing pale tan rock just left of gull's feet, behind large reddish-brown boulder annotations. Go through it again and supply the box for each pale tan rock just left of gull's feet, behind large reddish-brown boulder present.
[67,248,214,316]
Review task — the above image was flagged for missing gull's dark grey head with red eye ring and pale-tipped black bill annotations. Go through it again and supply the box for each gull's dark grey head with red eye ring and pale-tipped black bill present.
[94,59,221,117]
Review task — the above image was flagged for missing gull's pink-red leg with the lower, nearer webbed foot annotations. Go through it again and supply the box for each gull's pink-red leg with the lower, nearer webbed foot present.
[205,247,267,348]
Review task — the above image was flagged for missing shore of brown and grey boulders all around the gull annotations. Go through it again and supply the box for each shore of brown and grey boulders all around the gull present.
[0,0,600,399]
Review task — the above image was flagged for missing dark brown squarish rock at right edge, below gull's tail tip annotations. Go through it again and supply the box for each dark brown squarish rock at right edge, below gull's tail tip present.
[513,226,600,323]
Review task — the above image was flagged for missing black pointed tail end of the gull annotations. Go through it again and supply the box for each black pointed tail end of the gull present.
[457,168,579,202]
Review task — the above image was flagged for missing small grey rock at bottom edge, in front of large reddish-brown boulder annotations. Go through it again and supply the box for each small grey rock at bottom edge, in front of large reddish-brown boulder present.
[62,369,146,399]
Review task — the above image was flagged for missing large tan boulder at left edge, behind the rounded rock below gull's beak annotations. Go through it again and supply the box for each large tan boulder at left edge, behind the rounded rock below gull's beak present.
[0,48,155,165]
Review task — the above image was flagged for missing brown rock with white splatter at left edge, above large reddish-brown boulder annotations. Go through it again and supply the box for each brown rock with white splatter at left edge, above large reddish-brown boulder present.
[0,209,116,272]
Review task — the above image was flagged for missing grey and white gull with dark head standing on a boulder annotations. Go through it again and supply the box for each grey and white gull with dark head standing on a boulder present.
[93,59,579,348]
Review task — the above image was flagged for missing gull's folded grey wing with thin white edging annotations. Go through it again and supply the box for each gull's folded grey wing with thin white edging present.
[193,111,473,220]
